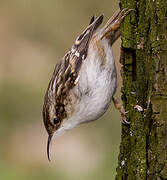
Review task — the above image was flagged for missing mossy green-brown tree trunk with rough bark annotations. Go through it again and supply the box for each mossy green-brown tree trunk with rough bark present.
[116,0,167,180]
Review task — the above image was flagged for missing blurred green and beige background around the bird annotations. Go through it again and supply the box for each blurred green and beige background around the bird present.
[0,0,121,180]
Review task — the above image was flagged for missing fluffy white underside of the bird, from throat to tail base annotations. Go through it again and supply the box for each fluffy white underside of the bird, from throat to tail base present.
[57,39,117,134]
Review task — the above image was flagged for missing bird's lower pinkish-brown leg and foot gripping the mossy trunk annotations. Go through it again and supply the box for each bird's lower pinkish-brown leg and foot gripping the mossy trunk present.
[112,97,130,124]
